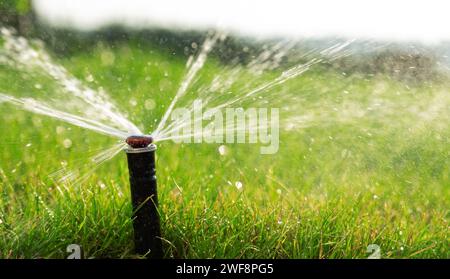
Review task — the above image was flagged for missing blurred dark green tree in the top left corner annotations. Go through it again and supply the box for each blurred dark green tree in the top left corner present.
[0,0,35,35]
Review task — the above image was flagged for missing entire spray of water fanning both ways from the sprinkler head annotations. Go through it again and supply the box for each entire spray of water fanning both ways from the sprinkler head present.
[0,28,418,186]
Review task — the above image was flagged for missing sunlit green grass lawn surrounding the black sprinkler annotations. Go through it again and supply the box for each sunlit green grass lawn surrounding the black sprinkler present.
[0,42,450,258]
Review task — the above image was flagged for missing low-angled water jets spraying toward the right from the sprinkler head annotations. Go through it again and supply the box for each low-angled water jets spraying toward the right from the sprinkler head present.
[154,40,353,141]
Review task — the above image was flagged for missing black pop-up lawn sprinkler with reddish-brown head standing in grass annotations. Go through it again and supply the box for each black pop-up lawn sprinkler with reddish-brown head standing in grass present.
[125,135,163,259]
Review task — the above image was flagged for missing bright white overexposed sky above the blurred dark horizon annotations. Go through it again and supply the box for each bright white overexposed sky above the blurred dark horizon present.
[34,0,450,42]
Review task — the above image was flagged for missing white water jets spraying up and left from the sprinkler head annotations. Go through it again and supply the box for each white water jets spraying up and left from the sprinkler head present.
[0,27,142,138]
